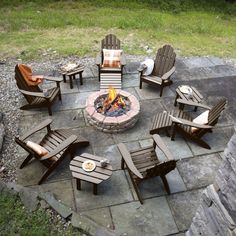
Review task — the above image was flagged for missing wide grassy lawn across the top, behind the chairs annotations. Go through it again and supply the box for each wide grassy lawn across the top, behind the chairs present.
[0,0,236,59]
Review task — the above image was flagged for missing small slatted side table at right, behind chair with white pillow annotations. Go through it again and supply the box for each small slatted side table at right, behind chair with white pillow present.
[174,86,203,111]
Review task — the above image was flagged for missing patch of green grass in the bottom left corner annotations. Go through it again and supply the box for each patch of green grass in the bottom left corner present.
[0,192,85,236]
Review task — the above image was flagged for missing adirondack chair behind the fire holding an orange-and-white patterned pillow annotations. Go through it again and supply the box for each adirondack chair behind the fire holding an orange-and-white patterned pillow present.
[95,34,126,81]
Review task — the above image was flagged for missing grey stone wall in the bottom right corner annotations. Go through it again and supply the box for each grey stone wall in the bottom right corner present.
[186,126,236,236]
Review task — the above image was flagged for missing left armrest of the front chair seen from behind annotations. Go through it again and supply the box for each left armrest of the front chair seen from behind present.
[117,143,143,179]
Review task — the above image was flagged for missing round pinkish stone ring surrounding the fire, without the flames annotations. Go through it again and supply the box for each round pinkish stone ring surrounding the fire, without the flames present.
[85,90,140,133]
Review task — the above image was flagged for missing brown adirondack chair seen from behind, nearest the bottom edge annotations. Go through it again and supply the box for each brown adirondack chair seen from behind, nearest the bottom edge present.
[117,134,177,204]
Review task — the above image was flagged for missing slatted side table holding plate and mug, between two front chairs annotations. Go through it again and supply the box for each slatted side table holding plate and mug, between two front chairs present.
[70,153,112,195]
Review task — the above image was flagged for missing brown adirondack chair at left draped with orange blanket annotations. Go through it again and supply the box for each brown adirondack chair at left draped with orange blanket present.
[15,64,62,116]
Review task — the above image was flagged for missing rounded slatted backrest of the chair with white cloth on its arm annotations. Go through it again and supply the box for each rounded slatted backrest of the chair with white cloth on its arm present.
[152,45,176,77]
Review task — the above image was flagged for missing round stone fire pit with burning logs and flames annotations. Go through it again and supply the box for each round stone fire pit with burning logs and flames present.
[85,88,140,133]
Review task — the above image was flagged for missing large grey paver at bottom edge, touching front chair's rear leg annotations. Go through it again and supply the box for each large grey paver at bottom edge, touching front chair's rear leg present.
[111,197,178,236]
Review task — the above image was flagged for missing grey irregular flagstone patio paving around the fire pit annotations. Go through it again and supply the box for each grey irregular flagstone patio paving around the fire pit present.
[17,56,236,236]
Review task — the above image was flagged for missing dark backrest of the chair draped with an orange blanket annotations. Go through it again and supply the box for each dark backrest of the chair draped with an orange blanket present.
[15,64,41,103]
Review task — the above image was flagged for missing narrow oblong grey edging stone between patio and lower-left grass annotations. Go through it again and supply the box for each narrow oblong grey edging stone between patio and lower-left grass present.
[39,192,72,219]
